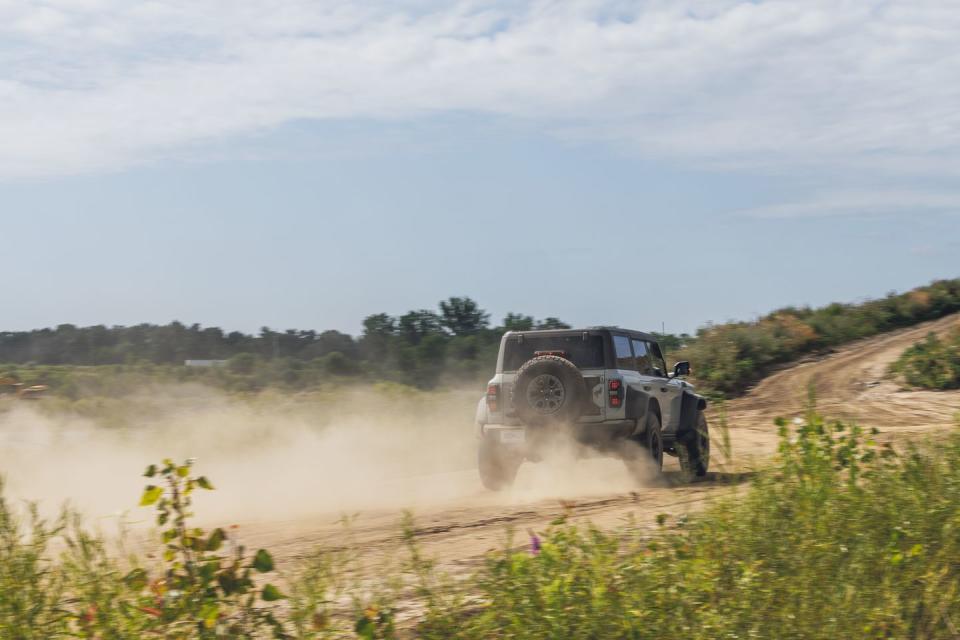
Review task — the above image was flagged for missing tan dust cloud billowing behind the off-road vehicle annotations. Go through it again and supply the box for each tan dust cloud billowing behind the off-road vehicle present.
[0,385,660,525]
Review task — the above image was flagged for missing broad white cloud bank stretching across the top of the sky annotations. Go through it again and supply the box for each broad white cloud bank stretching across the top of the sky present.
[0,0,960,177]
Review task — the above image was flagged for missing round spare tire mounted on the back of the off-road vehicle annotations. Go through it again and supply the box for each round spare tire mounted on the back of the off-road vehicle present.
[513,355,586,425]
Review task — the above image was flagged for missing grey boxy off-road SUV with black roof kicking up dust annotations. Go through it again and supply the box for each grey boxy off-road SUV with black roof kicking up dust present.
[476,327,710,490]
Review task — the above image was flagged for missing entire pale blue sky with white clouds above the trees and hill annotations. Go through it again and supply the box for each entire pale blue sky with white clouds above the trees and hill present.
[0,0,960,333]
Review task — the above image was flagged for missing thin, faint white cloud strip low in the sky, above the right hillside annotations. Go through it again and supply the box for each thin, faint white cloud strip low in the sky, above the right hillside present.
[740,188,960,218]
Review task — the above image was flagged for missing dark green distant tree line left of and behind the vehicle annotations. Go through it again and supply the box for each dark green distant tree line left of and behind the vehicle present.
[0,297,569,387]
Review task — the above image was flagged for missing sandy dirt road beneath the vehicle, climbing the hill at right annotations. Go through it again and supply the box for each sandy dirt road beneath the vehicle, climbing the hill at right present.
[241,314,960,573]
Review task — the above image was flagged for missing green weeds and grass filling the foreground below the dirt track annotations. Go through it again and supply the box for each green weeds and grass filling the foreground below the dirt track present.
[0,411,960,639]
